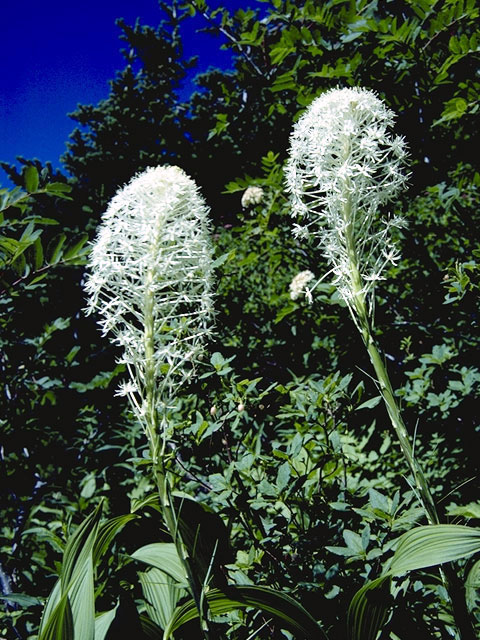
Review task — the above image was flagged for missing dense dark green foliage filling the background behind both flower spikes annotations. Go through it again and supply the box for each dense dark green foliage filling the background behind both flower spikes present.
[0,0,480,640]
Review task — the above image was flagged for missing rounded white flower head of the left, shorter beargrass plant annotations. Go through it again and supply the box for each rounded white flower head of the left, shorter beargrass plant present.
[85,167,213,418]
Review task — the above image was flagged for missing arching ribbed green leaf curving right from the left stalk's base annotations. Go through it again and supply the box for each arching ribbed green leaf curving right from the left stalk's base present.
[163,585,327,640]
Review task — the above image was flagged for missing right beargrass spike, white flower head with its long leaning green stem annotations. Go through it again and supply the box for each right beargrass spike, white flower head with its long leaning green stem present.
[286,88,480,638]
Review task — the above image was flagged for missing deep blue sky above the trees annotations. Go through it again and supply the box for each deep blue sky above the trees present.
[0,0,248,186]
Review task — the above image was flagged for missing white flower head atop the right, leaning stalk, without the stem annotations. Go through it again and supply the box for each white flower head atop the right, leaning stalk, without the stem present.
[286,88,407,304]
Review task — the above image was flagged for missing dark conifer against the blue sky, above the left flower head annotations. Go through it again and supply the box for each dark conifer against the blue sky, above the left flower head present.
[63,13,193,208]
